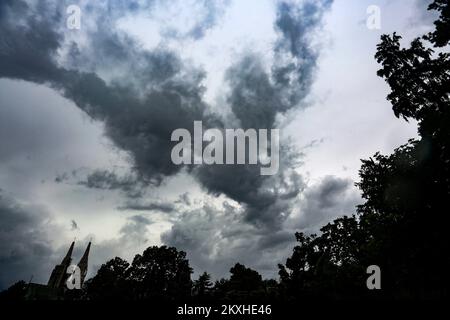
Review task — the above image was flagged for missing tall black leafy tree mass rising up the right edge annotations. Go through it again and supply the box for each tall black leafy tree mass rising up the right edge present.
[279,1,450,298]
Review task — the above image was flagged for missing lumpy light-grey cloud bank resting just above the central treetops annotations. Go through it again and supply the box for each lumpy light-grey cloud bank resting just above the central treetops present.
[161,176,361,278]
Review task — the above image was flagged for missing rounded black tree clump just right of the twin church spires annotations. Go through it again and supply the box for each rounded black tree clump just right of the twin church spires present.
[86,246,192,300]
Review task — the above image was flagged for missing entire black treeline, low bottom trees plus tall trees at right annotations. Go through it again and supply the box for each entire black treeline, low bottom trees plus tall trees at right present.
[2,0,450,301]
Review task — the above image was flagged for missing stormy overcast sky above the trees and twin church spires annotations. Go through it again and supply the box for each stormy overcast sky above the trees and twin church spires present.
[0,0,433,289]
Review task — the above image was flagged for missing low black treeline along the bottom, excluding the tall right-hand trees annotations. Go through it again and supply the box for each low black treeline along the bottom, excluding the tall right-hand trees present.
[0,246,279,302]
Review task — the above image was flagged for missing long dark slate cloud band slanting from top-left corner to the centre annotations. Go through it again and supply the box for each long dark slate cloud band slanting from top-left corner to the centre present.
[0,0,209,184]
